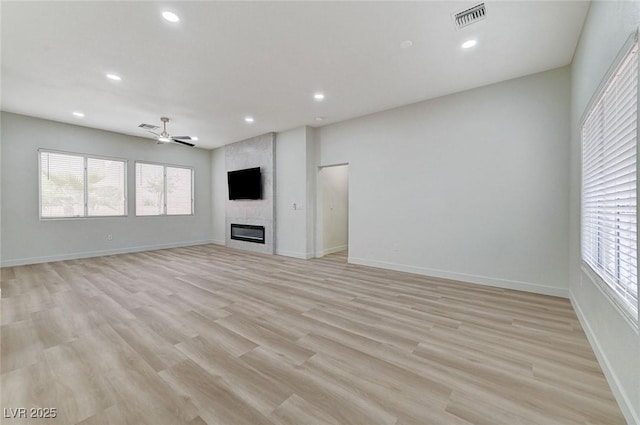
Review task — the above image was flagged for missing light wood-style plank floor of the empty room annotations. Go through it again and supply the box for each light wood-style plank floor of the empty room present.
[1,245,624,425]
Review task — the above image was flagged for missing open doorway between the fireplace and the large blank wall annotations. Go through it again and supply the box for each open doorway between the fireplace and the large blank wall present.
[316,164,349,262]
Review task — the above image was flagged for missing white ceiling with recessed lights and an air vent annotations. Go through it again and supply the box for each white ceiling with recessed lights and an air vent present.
[0,0,589,148]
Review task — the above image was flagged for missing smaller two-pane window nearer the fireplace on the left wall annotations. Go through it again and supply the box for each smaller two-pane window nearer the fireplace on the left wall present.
[136,162,193,216]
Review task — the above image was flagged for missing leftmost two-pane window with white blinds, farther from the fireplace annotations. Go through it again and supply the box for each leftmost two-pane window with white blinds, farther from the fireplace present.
[39,150,127,219]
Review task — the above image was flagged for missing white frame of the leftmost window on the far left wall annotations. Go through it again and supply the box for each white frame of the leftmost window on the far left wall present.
[37,148,129,221]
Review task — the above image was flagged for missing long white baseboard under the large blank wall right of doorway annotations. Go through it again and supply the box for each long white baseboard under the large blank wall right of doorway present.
[347,257,569,298]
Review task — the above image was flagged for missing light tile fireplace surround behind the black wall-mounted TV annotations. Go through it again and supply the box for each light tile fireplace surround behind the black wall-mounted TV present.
[225,133,275,254]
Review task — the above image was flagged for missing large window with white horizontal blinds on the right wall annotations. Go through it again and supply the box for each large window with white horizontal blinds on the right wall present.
[581,39,638,322]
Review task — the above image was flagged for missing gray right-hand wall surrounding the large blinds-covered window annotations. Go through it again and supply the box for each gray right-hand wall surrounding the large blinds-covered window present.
[569,1,640,424]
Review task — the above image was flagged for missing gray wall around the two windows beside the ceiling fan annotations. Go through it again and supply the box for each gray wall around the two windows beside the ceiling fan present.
[0,112,211,266]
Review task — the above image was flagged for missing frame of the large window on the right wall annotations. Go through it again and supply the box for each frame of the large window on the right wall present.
[578,31,640,324]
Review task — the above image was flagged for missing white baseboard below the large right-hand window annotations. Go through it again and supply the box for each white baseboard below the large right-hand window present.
[569,294,640,425]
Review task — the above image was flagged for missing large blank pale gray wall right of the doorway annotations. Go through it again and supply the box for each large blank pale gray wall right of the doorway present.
[317,67,570,296]
